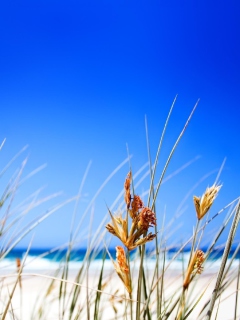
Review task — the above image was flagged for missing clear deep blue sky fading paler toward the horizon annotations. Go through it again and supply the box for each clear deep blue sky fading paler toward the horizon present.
[0,0,240,247]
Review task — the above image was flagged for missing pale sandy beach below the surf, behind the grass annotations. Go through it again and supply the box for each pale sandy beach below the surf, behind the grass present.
[1,270,240,320]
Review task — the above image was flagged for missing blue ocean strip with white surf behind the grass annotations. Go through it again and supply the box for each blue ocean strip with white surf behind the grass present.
[0,247,240,273]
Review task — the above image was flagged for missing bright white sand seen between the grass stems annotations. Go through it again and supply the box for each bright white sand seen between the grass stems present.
[1,271,240,320]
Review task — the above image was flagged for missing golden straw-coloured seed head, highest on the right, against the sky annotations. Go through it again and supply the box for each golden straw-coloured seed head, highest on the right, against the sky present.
[193,184,222,220]
